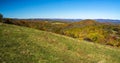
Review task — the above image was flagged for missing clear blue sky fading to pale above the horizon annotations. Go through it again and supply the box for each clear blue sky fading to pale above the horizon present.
[0,0,120,19]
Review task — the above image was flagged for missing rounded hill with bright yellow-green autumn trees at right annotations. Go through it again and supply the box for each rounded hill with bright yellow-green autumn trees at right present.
[62,19,120,47]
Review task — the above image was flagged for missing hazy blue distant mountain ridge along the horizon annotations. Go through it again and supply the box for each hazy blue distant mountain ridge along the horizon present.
[8,18,120,24]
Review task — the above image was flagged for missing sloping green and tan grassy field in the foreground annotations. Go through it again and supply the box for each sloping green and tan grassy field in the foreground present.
[0,23,120,63]
